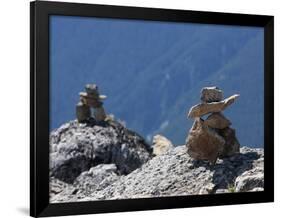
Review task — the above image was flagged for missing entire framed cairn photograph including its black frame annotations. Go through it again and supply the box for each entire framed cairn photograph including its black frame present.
[30,1,274,217]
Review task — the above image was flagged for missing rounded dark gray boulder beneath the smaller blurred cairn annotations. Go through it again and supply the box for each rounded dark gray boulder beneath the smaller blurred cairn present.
[50,119,152,183]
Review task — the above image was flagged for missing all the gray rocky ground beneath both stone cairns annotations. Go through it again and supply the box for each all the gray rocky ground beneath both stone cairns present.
[50,121,264,203]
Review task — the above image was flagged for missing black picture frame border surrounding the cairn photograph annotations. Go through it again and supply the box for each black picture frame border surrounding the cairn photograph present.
[30,1,274,217]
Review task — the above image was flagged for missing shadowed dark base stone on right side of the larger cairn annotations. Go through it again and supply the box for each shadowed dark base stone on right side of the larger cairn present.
[219,127,240,158]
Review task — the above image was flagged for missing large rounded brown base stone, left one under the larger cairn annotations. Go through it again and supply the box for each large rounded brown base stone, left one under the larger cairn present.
[186,119,225,163]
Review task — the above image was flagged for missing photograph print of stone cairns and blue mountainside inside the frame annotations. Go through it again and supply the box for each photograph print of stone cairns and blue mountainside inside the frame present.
[49,15,265,203]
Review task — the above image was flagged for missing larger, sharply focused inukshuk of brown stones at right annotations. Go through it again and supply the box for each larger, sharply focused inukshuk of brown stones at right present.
[186,87,240,164]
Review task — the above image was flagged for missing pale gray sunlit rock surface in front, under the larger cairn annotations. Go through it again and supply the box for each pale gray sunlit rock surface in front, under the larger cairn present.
[51,145,263,203]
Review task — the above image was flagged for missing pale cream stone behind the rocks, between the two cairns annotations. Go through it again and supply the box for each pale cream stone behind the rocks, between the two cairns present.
[152,135,174,155]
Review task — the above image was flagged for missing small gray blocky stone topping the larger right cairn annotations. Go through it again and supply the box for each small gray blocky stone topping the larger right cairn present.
[201,87,223,103]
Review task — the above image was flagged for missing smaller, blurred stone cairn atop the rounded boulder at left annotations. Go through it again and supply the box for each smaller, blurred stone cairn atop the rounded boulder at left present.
[76,84,106,123]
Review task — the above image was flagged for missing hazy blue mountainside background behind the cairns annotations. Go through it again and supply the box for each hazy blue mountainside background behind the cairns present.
[50,16,264,147]
